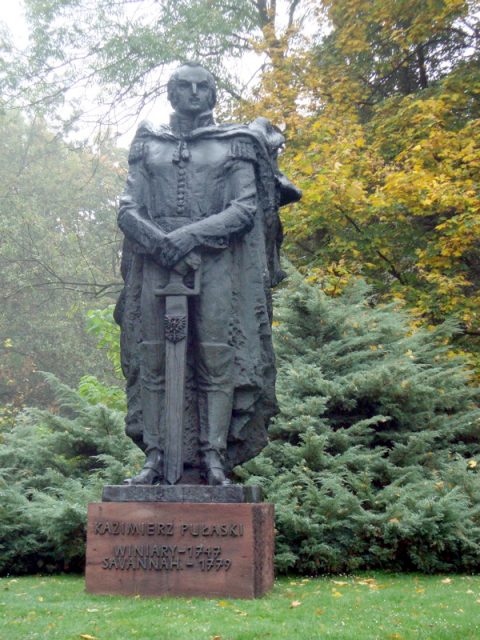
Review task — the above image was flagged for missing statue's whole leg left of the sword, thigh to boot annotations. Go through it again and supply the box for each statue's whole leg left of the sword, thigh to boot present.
[126,260,165,485]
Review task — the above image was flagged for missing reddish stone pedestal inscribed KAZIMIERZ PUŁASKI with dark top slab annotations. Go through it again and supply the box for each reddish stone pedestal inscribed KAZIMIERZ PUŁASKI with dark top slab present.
[86,486,274,598]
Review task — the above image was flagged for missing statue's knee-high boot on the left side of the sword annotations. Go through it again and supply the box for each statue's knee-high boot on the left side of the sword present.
[125,342,165,485]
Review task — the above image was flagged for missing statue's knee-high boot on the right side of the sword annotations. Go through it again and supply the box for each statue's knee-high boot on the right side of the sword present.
[197,343,233,485]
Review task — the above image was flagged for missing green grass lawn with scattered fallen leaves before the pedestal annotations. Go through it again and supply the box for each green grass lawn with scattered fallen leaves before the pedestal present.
[0,573,480,640]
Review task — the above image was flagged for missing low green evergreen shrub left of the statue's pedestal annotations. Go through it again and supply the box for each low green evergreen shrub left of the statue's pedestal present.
[0,374,139,574]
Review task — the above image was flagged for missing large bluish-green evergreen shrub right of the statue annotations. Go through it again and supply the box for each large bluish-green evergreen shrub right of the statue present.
[240,275,480,574]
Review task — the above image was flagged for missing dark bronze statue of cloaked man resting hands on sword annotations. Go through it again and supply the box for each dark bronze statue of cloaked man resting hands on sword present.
[115,64,300,485]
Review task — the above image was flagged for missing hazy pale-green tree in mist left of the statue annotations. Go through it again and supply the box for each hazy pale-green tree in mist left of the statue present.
[0,114,123,403]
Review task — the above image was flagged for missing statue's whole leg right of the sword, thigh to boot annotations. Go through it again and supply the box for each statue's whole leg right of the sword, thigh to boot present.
[195,252,234,484]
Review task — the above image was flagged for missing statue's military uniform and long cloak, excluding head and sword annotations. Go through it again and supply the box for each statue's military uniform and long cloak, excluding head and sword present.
[117,114,300,480]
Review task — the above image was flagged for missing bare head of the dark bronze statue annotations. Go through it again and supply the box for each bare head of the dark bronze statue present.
[167,62,217,116]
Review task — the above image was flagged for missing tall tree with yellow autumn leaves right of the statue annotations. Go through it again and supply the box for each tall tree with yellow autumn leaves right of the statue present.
[236,0,480,364]
